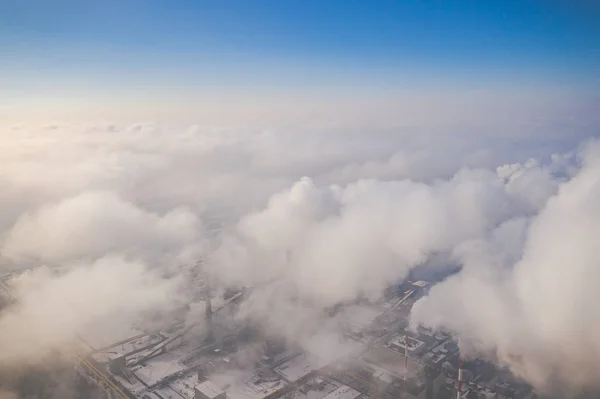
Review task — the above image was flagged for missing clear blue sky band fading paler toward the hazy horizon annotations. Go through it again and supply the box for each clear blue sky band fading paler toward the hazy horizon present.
[0,0,600,123]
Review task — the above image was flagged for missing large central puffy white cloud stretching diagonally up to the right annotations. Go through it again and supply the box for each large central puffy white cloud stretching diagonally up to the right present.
[211,156,572,335]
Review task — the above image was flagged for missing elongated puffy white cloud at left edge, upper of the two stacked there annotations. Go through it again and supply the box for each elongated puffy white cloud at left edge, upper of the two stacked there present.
[0,191,200,264]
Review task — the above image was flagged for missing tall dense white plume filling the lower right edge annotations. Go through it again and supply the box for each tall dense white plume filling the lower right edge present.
[413,143,600,396]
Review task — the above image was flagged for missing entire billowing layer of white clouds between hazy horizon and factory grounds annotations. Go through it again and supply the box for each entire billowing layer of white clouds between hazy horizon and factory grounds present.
[0,124,600,396]
